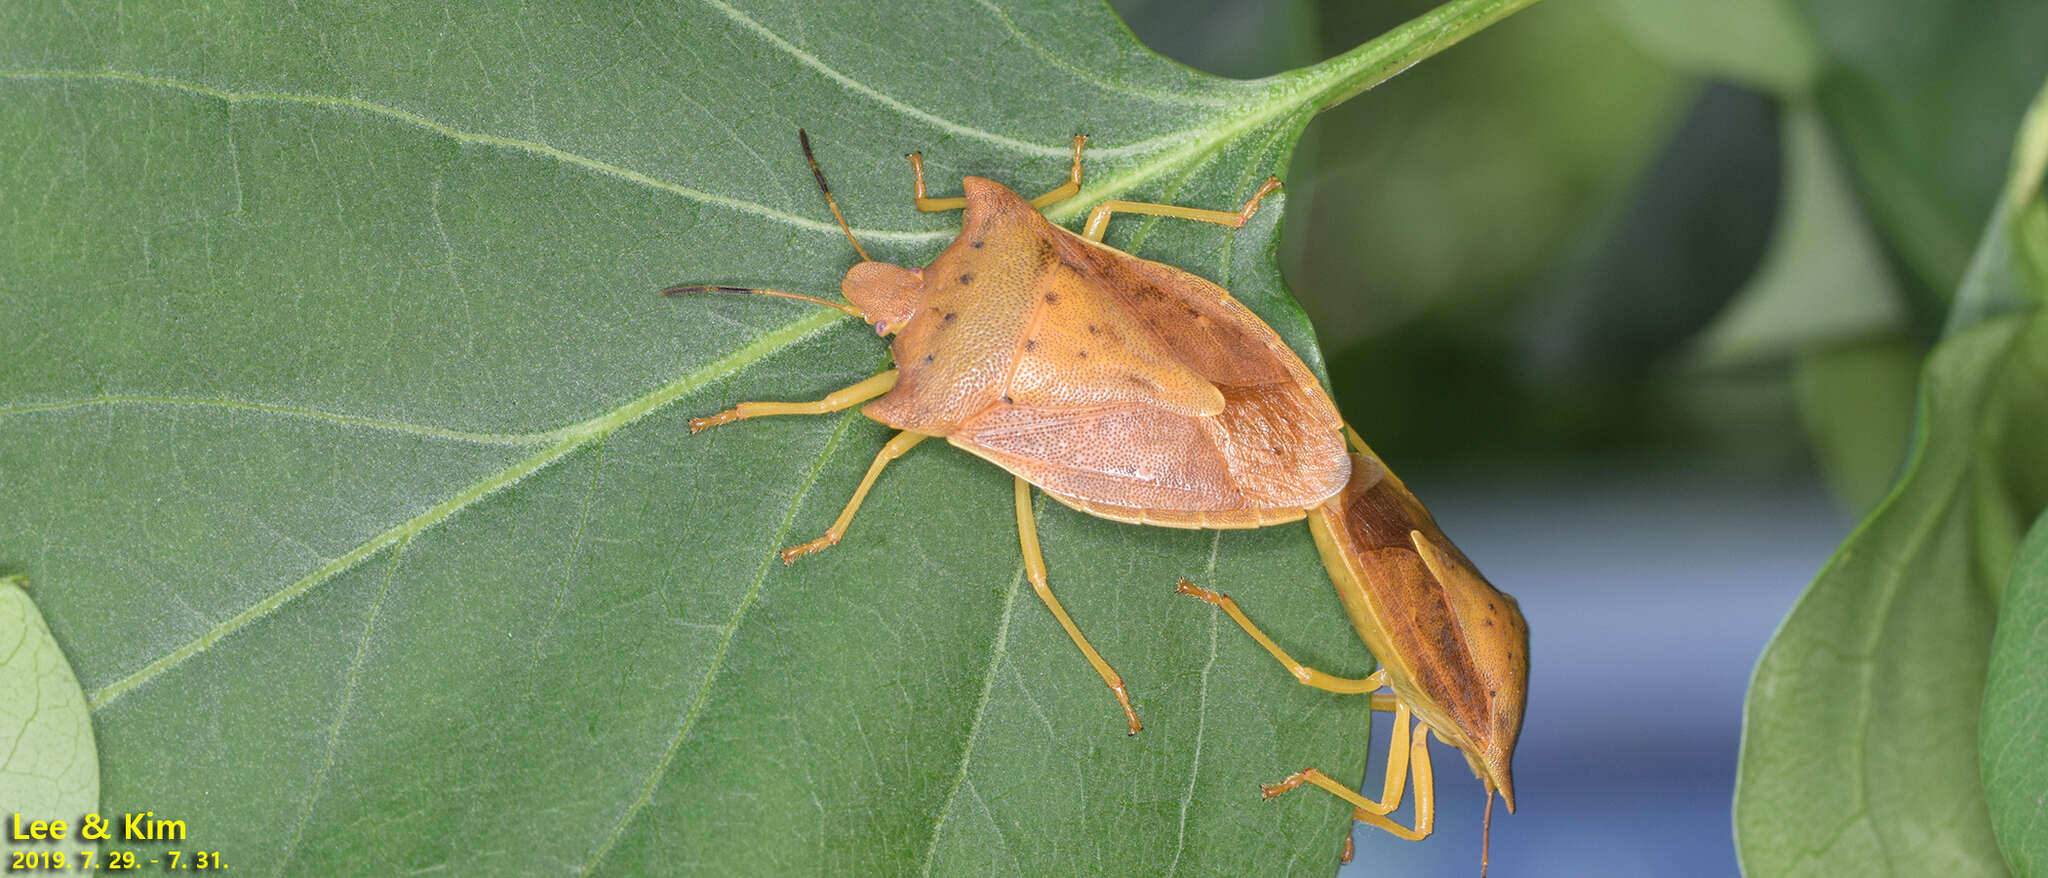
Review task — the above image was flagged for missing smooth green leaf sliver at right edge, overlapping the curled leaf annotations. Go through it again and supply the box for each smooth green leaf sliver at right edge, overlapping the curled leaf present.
[1982,516,2048,876]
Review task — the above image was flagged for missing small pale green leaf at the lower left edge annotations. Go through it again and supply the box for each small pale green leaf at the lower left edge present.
[0,575,100,864]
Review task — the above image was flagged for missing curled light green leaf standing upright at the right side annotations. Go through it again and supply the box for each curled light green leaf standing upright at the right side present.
[1735,78,2048,878]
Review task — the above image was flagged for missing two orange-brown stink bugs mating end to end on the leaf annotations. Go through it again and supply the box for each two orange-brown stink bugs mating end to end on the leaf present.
[666,131,1528,872]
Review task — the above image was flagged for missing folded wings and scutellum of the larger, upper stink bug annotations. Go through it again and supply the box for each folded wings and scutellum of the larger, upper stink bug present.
[950,222,1350,519]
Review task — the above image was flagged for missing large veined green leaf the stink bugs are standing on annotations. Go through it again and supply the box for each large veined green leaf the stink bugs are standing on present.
[0,0,1532,874]
